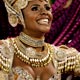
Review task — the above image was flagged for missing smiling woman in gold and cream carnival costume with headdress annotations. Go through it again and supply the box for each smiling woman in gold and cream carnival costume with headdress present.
[0,0,80,80]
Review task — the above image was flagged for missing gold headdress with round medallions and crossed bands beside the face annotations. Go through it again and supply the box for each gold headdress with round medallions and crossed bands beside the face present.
[3,0,31,27]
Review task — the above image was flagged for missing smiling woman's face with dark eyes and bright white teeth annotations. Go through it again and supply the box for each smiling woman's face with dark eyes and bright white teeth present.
[22,0,52,35]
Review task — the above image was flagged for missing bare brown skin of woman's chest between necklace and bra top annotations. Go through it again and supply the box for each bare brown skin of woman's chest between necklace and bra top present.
[13,56,55,80]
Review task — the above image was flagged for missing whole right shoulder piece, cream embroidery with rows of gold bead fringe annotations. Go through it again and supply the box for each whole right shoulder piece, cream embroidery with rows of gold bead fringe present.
[50,45,80,73]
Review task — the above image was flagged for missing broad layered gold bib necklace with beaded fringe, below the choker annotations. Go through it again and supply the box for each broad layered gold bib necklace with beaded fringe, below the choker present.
[12,32,54,67]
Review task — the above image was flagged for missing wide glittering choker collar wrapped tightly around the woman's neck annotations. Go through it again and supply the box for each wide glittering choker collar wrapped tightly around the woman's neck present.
[19,32,44,47]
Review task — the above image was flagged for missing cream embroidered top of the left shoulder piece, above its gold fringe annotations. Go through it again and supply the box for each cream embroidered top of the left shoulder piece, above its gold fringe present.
[0,39,14,58]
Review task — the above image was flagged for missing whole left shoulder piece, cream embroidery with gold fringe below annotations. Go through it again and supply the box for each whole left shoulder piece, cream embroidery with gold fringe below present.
[0,39,14,72]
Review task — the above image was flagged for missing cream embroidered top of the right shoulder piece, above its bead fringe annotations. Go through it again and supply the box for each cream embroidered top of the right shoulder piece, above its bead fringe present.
[52,45,79,61]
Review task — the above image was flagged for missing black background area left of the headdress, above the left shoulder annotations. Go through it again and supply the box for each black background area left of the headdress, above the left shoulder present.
[0,0,23,39]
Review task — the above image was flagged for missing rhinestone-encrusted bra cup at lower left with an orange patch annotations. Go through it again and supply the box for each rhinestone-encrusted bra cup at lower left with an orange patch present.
[9,66,34,80]
